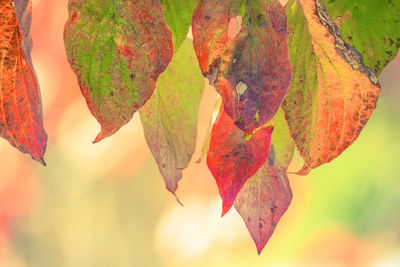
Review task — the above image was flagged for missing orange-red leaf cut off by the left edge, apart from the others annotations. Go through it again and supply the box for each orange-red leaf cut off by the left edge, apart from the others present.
[0,0,47,165]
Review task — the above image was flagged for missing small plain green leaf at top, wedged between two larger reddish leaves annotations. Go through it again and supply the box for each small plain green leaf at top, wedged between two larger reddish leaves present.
[161,0,199,53]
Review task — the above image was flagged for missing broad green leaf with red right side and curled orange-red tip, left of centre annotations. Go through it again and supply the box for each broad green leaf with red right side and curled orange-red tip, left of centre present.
[64,0,173,142]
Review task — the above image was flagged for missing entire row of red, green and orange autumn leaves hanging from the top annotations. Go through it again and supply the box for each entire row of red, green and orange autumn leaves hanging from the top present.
[0,0,400,253]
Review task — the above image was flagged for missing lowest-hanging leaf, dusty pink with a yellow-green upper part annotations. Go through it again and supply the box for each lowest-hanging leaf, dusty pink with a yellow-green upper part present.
[235,109,294,254]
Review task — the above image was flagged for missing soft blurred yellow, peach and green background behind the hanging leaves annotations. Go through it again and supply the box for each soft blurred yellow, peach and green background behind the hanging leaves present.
[0,0,400,267]
